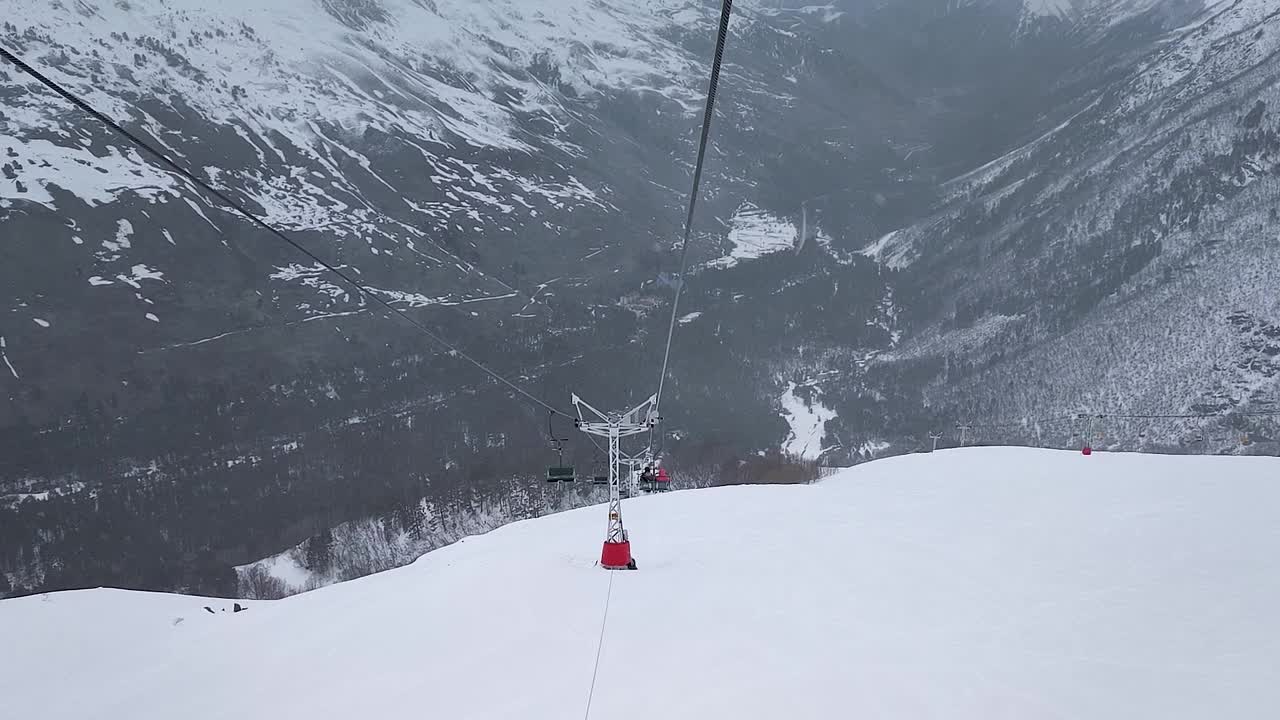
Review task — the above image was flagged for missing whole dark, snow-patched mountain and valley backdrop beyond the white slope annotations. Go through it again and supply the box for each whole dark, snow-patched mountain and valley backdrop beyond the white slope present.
[0,0,1280,593]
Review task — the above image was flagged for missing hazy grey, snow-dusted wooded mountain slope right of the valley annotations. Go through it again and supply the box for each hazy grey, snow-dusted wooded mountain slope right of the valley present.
[849,0,1280,447]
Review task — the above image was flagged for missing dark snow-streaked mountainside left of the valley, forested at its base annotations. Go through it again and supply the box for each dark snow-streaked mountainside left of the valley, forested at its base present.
[0,0,906,592]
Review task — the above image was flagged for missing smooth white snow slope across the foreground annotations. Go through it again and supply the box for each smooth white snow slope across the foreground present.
[0,448,1280,720]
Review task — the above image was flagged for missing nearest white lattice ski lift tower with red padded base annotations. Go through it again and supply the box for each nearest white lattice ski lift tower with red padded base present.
[573,395,658,570]
